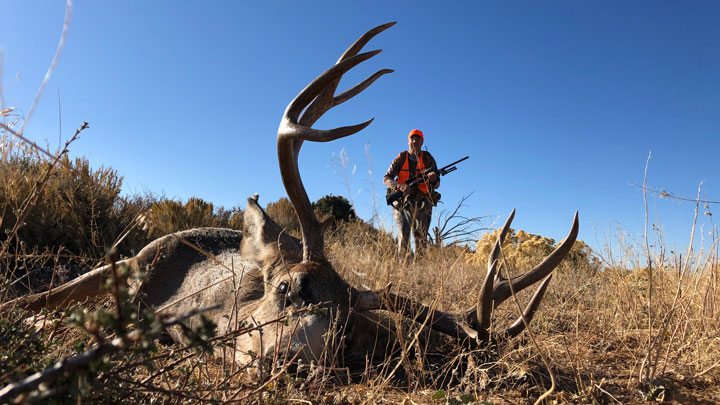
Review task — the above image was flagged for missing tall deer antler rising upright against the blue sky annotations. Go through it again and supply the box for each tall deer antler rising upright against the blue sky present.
[277,22,395,262]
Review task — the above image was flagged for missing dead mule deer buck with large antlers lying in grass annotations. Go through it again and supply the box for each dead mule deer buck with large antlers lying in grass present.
[6,22,578,362]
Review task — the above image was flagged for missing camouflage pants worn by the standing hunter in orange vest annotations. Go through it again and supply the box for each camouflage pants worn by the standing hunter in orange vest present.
[393,197,432,256]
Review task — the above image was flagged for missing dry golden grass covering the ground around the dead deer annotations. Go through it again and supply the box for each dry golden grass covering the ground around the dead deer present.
[3,188,720,403]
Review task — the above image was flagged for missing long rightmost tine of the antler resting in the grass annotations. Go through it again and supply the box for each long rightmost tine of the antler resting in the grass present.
[493,211,580,306]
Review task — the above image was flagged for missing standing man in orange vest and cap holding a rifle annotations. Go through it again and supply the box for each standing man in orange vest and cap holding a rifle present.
[383,129,440,259]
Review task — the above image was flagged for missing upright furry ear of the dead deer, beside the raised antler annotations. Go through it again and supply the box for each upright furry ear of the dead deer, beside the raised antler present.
[240,194,302,268]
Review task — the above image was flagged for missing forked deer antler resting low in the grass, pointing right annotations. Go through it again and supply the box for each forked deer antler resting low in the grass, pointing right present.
[354,210,579,345]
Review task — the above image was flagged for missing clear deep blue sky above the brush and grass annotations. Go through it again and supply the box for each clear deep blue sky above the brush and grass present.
[0,0,720,256]
